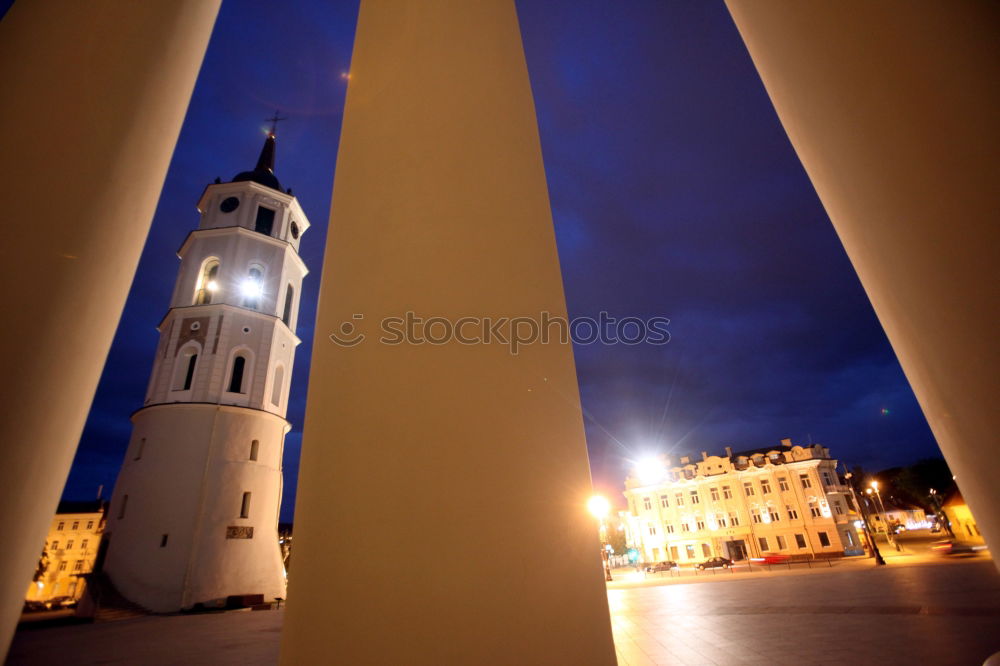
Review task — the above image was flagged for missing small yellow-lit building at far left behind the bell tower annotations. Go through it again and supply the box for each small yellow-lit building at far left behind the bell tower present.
[25,501,104,602]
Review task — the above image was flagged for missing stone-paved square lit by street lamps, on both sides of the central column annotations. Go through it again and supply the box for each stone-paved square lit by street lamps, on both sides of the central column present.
[7,558,1000,666]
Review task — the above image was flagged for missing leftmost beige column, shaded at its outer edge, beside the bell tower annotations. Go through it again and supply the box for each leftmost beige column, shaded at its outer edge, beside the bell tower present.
[0,0,219,651]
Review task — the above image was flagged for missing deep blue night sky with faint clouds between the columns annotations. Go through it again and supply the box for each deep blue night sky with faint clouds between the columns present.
[58,0,938,520]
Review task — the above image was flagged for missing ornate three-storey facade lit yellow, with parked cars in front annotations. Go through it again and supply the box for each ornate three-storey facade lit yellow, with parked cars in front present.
[625,439,861,564]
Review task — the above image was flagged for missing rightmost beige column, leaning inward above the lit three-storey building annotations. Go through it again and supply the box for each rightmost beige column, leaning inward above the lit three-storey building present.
[727,0,1000,551]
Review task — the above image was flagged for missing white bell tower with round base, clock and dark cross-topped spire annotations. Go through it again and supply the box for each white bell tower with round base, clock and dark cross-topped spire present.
[104,126,309,612]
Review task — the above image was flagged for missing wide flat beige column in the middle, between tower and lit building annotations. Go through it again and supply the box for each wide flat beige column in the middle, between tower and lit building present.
[282,0,615,664]
